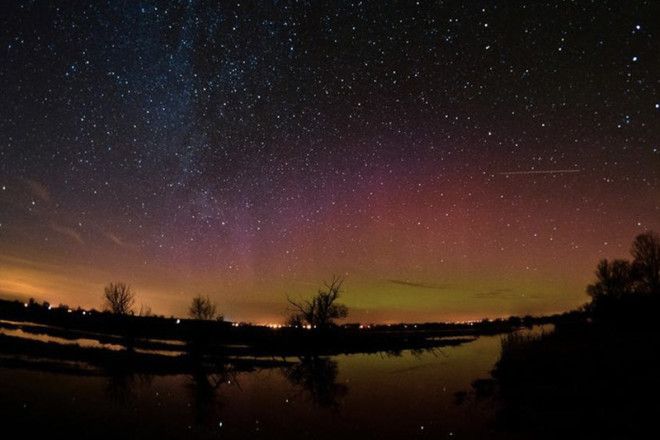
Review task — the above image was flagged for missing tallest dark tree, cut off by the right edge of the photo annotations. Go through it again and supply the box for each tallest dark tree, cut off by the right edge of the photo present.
[630,231,660,294]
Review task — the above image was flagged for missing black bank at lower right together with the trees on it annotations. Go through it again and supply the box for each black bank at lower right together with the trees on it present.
[458,231,660,439]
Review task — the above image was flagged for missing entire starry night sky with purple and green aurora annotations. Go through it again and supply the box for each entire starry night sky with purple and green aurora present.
[0,0,660,322]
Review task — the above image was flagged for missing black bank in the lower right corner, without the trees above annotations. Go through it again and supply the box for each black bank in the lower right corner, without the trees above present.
[459,300,660,439]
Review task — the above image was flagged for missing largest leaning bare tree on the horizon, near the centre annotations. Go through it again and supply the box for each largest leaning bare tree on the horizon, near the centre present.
[287,276,348,328]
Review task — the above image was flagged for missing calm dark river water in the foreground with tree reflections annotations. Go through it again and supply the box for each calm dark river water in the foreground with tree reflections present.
[0,336,540,439]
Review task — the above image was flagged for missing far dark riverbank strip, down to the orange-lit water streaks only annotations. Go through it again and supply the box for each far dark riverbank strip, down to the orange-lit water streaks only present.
[0,300,564,357]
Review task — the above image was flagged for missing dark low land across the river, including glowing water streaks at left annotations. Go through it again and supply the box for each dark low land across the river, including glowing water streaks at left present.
[0,301,549,374]
